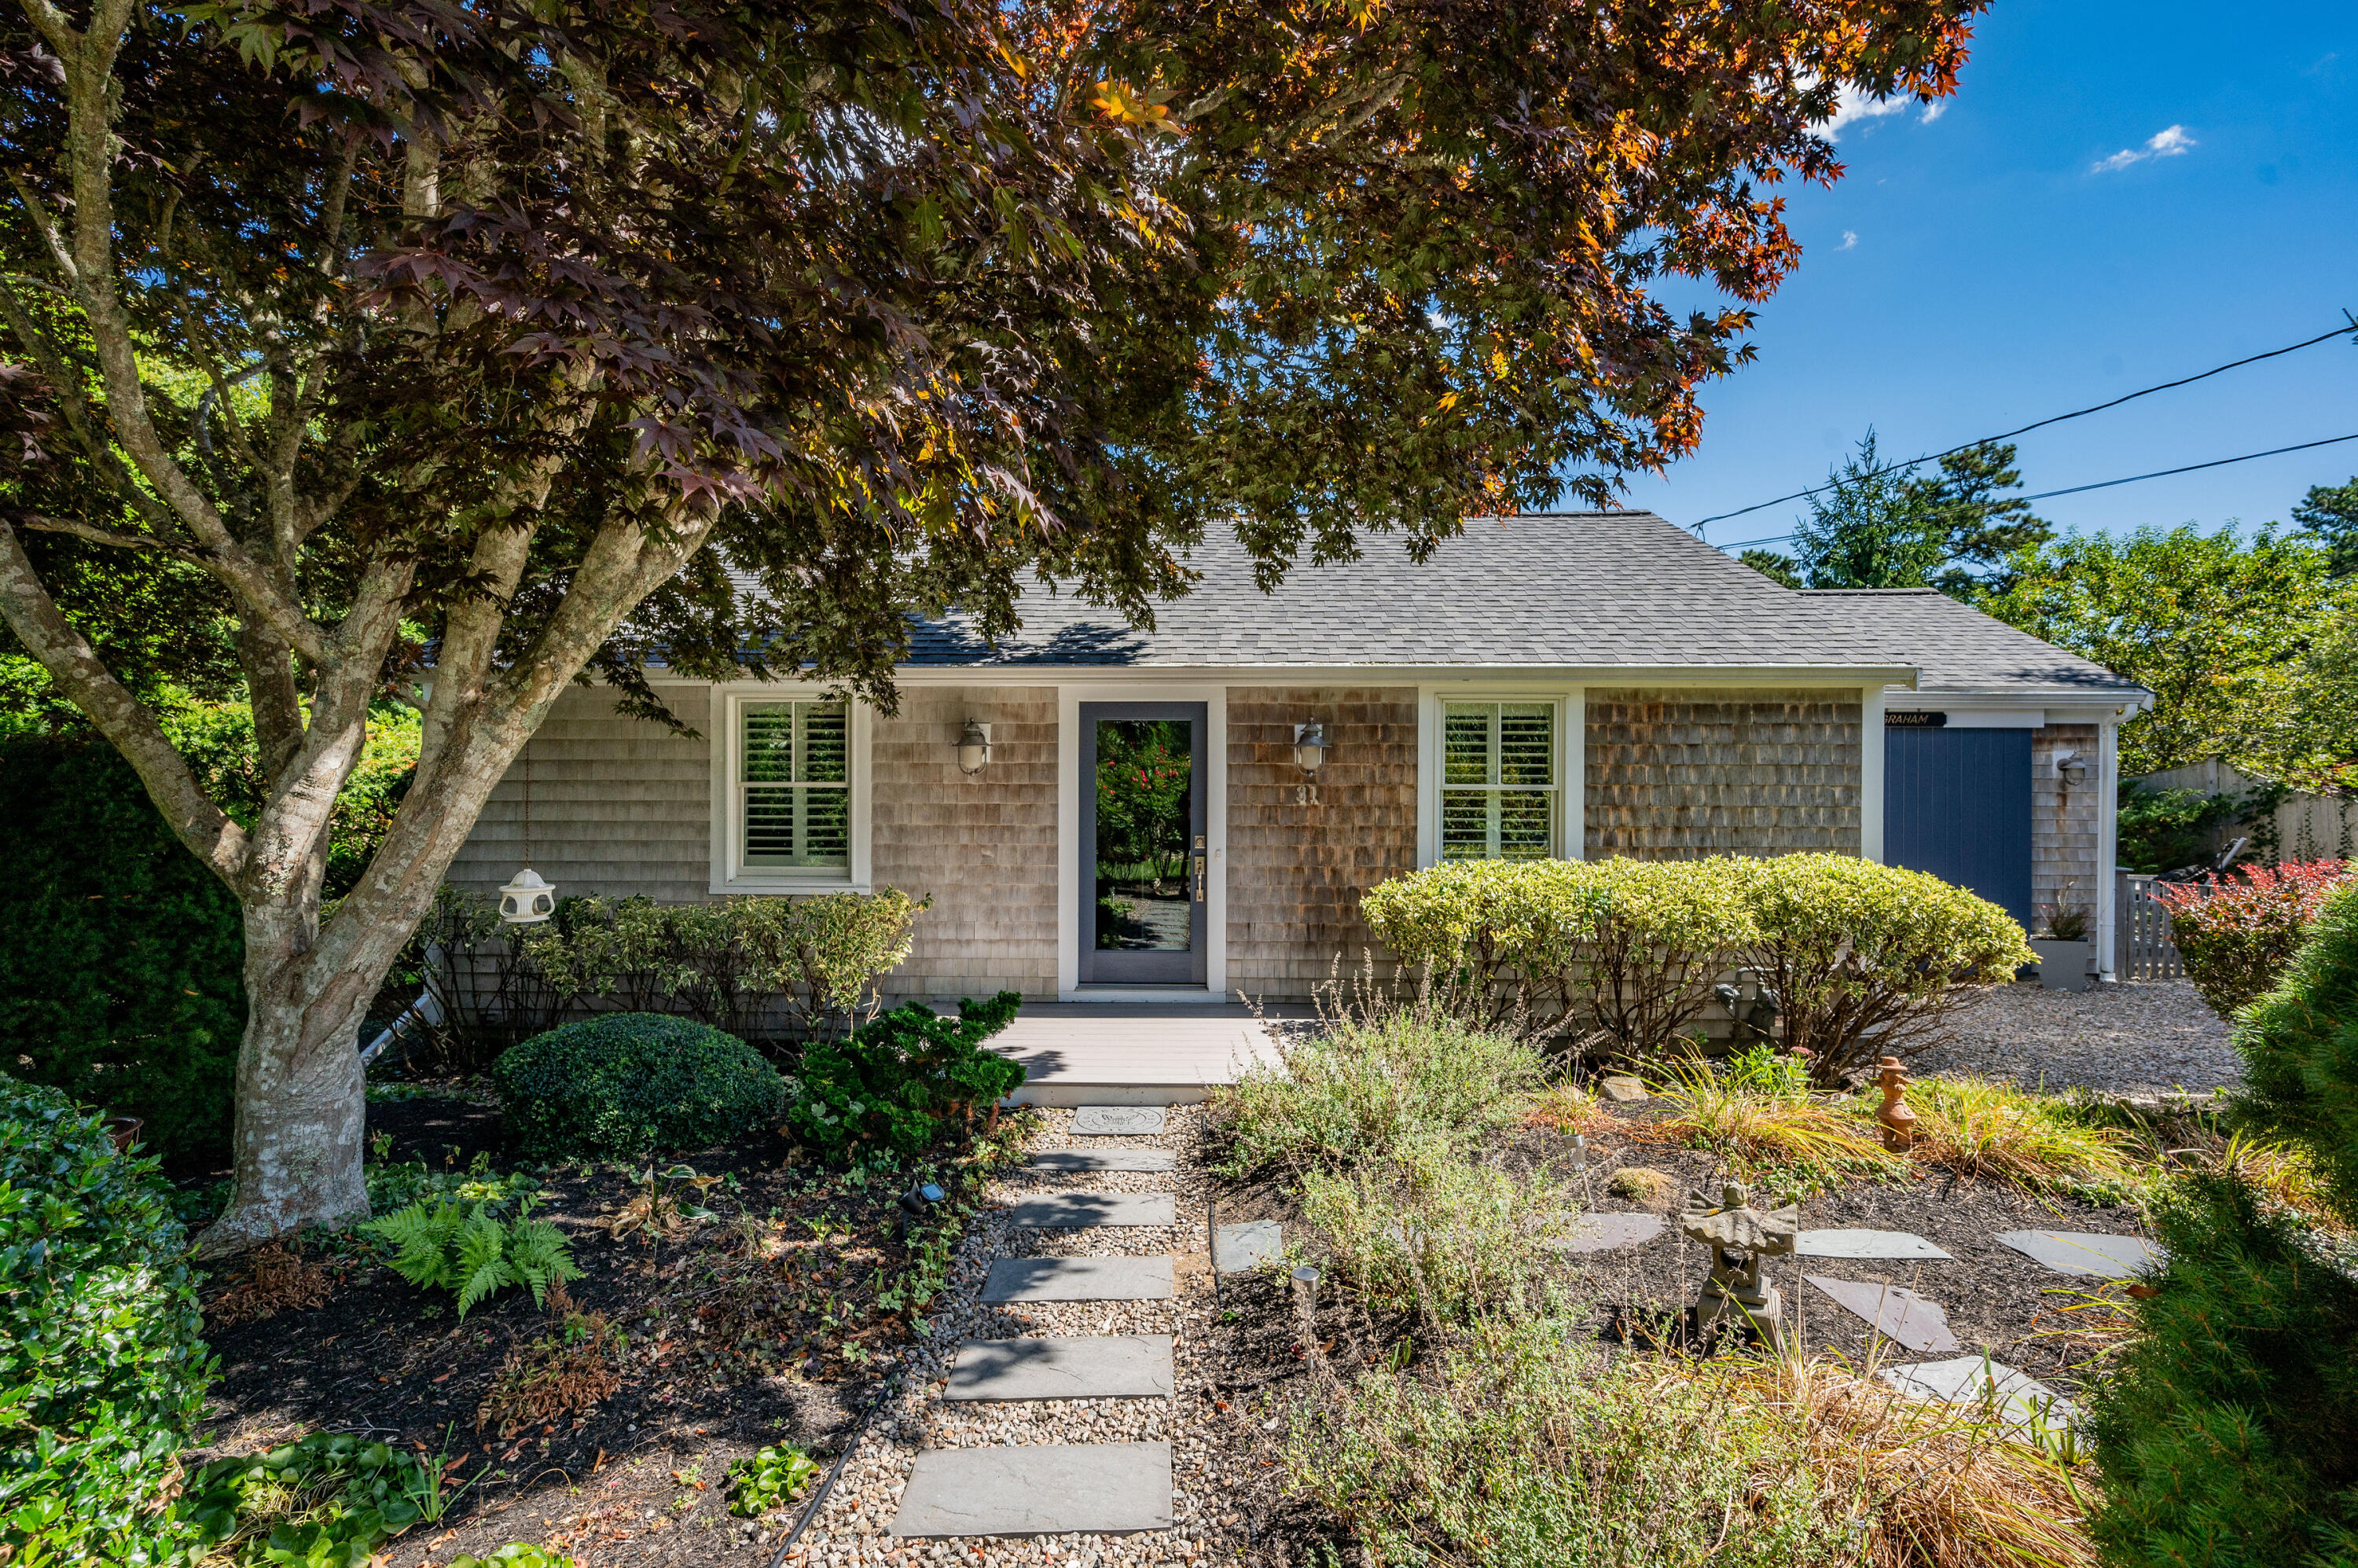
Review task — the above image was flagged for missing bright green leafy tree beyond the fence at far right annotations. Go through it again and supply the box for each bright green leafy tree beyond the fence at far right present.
[1981,523,2351,778]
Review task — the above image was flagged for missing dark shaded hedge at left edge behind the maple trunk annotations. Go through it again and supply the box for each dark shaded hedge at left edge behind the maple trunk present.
[0,736,245,1158]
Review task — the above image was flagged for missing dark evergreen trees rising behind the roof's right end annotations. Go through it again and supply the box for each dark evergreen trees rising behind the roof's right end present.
[1740,429,2054,599]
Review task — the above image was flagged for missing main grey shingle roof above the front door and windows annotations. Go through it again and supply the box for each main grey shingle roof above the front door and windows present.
[910,512,1917,667]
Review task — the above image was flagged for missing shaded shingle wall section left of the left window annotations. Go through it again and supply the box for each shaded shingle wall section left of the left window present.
[446,686,712,903]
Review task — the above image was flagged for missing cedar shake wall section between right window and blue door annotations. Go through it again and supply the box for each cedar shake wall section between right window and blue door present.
[1582,686,1882,861]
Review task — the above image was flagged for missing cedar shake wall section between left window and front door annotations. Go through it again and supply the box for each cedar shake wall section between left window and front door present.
[868,686,1056,1002]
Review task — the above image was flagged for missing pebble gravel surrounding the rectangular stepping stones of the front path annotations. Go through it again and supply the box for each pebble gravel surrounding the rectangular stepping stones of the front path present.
[788,1106,1245,1568]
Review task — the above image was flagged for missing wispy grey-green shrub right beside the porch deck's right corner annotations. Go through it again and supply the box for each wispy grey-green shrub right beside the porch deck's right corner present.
[1214,1007,1542,1177]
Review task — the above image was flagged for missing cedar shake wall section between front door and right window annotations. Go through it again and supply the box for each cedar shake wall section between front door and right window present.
[1229,686,1417,1000]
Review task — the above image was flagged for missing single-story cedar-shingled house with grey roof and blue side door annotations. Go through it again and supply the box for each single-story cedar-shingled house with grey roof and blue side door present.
[450,512,2150,1002]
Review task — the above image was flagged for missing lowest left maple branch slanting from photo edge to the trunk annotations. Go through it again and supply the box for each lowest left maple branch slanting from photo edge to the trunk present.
[0,523,248,889]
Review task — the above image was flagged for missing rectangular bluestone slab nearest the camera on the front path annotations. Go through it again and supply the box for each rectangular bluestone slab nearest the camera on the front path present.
[891,1443,1172,1535]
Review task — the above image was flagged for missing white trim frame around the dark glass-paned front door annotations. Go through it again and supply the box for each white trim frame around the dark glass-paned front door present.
[1056,681,1229,1002]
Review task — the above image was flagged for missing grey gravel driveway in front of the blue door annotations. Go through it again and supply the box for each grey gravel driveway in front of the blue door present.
[1908,981,2242,1094]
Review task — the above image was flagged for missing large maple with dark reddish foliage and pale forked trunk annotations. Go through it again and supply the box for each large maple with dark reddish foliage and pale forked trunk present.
[0,0,1981,1252]
